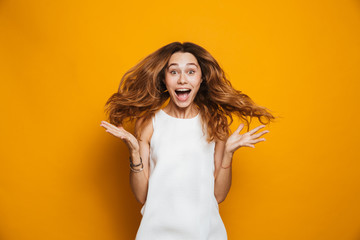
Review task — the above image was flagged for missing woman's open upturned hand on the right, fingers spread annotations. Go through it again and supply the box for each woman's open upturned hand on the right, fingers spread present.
[225,123,269,153]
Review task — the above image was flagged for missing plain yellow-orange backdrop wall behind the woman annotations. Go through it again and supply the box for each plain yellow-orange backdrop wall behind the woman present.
[0,0,360,240]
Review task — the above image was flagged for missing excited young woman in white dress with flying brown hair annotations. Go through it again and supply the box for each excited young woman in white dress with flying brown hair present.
[101,42,275,240]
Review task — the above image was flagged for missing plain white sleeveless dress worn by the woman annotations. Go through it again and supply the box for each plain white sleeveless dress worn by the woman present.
[136,110,227,240]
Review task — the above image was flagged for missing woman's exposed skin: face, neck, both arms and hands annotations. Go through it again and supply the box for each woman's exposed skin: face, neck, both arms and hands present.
[100,52,269,204]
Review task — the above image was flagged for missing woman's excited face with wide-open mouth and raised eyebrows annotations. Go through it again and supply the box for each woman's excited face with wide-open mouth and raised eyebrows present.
[165,52,202,108]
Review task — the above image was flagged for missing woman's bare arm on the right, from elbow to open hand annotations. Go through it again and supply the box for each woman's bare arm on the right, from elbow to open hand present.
[214,123,269,203]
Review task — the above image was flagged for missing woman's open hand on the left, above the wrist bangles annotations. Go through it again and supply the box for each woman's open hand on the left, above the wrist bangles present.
[100,121,140,154]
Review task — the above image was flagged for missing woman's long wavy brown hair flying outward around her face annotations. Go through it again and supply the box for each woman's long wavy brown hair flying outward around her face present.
[105,42,275,142]
